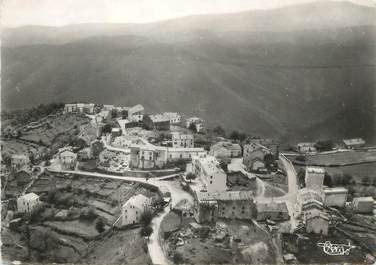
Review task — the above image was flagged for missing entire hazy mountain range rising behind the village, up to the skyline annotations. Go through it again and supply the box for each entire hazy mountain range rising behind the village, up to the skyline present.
[2,2,376,141]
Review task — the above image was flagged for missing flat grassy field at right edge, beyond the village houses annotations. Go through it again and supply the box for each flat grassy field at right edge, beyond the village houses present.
[306,151,376,166]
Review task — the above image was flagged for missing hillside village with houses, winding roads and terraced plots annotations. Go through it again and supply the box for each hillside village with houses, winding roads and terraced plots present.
[1,100,376,264]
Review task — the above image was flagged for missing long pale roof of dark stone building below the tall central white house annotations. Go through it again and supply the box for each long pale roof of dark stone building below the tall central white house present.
[196,191,253,201]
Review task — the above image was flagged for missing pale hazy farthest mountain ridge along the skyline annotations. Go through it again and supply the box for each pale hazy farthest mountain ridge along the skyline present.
[2,1,376,46]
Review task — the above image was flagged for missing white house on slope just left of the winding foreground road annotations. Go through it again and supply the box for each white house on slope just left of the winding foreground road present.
[122,194,151,225]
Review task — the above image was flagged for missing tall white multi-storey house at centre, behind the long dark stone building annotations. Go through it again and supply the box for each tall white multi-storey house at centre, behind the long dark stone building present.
[192,154,227,192]
